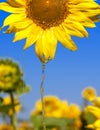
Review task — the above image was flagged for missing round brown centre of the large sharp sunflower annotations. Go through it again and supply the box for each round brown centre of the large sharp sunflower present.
[27,0,68,29]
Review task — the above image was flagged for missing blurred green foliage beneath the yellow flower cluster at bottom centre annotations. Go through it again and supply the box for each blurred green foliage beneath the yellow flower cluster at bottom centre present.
[30,115,74,130]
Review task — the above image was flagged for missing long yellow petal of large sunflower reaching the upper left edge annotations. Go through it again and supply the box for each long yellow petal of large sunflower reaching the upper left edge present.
[0,2,25,13]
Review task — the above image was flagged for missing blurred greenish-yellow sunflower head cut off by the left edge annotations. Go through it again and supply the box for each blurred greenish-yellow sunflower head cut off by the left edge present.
[0,59,22,91]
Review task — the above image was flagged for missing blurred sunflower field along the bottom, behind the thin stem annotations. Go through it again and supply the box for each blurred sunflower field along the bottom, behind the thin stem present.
[0,59,100,130]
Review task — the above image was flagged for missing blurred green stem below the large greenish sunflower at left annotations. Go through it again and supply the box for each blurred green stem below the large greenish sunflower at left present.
[10,92,17,130]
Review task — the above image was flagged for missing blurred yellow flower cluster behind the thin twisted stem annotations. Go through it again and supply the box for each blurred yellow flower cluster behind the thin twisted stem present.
[32,96,81,119]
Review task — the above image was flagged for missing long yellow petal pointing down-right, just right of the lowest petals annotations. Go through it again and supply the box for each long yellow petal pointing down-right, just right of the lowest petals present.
[54,27,77,51]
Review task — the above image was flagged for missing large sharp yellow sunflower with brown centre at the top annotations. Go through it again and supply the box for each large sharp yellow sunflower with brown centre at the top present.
[0,0,100,62]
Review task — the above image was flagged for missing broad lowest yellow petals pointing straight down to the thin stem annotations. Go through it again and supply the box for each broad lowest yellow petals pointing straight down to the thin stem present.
[35,30,57,62]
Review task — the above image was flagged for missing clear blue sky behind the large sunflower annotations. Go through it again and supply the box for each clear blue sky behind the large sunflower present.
[0,0,100,118]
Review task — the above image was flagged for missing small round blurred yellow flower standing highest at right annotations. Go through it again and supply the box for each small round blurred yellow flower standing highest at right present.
[82,87,96,101]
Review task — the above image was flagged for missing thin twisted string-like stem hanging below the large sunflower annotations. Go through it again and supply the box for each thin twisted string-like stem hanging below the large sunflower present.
[40,64,46,130]
